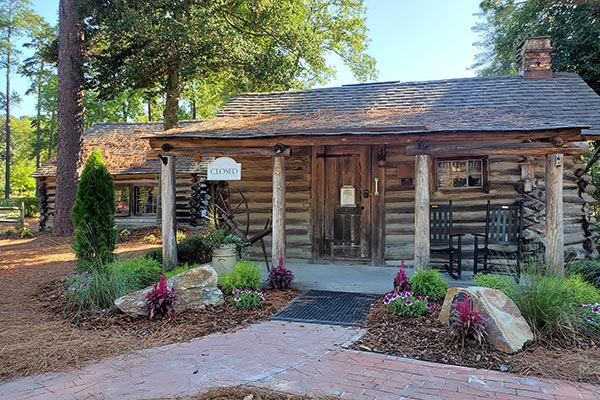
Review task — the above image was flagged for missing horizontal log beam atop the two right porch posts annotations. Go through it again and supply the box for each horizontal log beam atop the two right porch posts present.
[406,142,590,157]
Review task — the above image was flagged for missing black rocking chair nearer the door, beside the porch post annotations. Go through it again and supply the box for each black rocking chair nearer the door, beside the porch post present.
[429,201,463,279]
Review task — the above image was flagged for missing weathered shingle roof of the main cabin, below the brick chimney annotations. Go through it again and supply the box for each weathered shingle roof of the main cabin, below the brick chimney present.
[154,73,600,138]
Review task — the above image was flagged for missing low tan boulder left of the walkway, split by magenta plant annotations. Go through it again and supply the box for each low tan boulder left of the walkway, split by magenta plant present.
[115,265,224,316]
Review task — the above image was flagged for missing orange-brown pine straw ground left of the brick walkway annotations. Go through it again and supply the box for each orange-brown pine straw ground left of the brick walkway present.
[0,232,298,382]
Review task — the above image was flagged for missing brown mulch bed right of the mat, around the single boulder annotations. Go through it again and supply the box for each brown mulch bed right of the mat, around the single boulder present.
[353,300,600,384]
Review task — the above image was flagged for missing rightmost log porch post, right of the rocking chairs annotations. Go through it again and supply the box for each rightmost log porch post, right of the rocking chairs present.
[545,153,565,277]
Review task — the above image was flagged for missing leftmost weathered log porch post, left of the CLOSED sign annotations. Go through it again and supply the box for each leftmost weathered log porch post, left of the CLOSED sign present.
[160,156,177,271]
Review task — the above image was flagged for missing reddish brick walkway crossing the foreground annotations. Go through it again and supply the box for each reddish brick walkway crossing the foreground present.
[0,321,600,400]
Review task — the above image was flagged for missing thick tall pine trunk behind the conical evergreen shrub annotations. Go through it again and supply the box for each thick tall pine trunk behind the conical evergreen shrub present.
[54,0,83,236]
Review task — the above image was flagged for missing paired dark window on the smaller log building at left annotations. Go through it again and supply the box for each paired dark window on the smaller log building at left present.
[115,185,158,217]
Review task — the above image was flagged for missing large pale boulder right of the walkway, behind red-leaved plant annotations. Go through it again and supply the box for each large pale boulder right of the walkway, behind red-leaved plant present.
[439,286,533,354]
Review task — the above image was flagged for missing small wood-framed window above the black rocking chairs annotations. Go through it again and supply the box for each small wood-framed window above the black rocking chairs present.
[436,158,487,190]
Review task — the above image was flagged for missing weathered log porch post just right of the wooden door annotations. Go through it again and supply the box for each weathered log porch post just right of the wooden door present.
[414,155,430,271]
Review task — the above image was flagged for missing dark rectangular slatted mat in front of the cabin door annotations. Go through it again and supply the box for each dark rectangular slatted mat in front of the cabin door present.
[271,290,379,326]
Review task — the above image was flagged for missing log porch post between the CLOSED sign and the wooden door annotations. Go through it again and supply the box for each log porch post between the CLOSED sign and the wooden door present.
[271,154,285,266]
